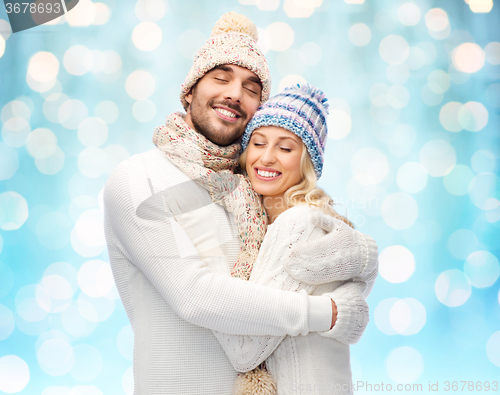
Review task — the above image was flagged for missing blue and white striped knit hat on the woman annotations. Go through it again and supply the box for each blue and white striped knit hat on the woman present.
[241,84,328,178]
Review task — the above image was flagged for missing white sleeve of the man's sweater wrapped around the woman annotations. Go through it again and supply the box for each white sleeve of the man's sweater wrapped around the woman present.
[104,161,331,336]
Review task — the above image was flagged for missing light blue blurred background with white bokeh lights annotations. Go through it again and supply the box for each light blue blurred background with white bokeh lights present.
[0,0,500,395]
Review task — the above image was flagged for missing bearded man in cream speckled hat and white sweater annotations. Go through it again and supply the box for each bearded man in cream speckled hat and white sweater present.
[104,13,368,395]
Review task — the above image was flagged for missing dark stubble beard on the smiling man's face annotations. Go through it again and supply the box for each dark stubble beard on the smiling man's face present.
[189,90,247,146]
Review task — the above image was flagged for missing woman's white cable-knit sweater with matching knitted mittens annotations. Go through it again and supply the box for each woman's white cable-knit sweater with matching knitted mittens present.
[215,206,378,395]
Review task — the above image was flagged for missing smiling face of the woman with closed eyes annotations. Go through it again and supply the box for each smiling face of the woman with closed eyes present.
[246,126,304,197]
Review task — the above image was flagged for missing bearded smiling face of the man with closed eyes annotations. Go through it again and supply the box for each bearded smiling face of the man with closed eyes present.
[186,64,262,146]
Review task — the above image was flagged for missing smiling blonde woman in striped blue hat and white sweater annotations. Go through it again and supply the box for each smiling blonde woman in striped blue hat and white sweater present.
[212,85,377,394]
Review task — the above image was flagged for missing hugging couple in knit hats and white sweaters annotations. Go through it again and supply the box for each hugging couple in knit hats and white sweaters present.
[104,12,378,395]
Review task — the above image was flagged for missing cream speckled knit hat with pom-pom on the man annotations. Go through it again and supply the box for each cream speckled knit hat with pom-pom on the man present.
[180,11,271,109]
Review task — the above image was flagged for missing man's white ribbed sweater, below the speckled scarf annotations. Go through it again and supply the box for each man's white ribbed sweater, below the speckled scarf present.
[104,148,331,395]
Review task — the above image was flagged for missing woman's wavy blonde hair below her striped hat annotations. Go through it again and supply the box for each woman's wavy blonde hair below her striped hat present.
[239,143,354,228]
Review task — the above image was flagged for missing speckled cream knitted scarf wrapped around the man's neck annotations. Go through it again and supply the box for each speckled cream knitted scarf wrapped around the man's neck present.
[153,113,267,280]
